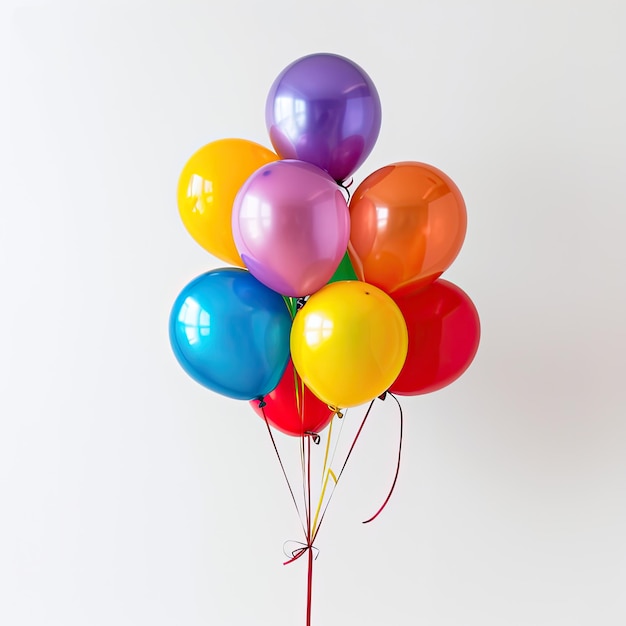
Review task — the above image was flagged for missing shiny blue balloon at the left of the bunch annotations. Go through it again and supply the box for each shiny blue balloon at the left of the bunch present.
[169,268,291,400]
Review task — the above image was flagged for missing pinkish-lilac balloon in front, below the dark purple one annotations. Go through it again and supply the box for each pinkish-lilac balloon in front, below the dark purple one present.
[232,160,350,298]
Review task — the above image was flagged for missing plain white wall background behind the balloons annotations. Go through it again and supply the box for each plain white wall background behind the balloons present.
[0,0,626,626]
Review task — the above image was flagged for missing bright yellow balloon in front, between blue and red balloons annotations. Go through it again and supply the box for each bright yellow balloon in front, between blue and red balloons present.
[291,280,408,408]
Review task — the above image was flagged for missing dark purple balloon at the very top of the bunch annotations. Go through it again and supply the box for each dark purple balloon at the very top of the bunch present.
[265,54,381,182]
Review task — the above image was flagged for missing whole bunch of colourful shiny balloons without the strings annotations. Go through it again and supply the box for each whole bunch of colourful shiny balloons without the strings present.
[169,54,480,424]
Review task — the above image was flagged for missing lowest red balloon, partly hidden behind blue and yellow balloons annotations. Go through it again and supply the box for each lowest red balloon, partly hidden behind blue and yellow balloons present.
[250,359,334,437]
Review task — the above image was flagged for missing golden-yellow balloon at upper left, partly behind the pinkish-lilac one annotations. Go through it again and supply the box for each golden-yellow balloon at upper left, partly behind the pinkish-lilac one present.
[178,139,279,267]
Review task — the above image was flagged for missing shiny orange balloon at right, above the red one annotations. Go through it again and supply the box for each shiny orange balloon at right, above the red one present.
[348,161,467,295]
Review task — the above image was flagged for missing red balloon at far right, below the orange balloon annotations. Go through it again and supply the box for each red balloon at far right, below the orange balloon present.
[389,279,480,396]
